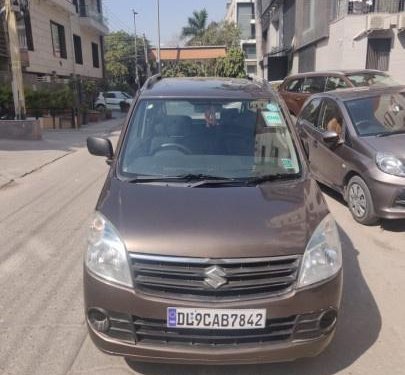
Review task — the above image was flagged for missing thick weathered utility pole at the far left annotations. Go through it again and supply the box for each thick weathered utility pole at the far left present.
[5,0,25,120]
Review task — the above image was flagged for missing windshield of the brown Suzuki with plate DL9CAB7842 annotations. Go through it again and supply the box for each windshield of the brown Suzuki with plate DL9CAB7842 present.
[119,99,301,179]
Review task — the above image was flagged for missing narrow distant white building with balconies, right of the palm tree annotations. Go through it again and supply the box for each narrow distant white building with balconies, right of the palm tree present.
[225,0,257,75]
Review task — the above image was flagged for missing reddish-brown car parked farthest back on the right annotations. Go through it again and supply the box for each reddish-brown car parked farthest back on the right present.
[279,69,398,116]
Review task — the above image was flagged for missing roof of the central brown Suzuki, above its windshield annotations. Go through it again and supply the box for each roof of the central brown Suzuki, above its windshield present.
[141,76,275,100]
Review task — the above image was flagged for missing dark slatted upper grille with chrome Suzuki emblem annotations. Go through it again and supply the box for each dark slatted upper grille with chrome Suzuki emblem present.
[130,254,301,301]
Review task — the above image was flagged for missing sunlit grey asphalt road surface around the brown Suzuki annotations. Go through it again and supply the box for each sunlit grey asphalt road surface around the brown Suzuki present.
[0,134,405,375]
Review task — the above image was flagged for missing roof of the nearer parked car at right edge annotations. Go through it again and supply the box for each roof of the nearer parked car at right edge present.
[311,85,405,101]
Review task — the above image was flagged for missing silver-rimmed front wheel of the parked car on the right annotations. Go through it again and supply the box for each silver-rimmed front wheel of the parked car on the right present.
[347,176,379,225]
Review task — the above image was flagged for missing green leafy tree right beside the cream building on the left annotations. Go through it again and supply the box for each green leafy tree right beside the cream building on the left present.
[105,31,150,90]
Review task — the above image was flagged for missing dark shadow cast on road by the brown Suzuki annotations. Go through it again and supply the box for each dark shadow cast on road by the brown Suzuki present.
[124,229,381,375]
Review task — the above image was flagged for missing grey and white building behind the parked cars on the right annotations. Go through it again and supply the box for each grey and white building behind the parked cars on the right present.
[257,0,405,83]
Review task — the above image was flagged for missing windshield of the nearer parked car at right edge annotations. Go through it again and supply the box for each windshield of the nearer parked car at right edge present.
[346,91,405,136]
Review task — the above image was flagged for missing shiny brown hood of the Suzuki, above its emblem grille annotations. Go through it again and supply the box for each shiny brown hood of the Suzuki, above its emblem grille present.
[97,178,328,258]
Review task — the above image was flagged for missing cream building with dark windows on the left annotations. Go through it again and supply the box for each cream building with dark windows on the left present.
[6,0,108,85]
